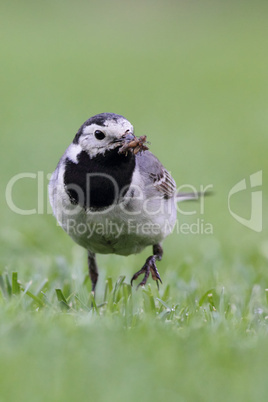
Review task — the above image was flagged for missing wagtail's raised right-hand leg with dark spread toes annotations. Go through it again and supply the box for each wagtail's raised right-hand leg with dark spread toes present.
[130,244,163,287]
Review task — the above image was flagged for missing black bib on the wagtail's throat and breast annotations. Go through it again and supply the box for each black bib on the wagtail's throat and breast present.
[64,149,135,209]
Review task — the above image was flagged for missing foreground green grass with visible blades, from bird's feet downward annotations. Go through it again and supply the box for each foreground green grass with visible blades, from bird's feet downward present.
[0,264,268,401]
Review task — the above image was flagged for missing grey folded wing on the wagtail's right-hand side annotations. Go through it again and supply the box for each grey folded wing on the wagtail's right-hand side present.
[136,151,176,199]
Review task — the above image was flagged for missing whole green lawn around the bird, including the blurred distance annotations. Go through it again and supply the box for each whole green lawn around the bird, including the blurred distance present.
[0,0,268,402]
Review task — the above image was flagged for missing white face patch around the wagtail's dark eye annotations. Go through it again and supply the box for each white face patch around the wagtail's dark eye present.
[79,118,134,157]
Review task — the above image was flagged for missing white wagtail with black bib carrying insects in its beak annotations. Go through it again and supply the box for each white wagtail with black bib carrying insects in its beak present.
[49,113,200,292]
